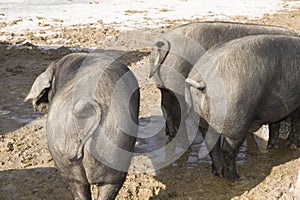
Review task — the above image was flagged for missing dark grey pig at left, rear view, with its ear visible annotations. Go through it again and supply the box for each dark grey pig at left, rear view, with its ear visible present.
[26,53,139,199]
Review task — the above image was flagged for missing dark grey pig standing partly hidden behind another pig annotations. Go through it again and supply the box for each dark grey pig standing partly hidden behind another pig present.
[150,22,298,141]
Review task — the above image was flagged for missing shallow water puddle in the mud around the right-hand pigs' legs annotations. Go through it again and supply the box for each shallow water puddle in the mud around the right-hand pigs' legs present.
[135,115,262,173]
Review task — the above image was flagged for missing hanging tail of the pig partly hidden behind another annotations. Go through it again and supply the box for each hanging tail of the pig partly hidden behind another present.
[149,38,170,78]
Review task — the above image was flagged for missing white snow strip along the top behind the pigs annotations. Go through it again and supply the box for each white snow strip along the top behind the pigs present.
[0,0,300,34]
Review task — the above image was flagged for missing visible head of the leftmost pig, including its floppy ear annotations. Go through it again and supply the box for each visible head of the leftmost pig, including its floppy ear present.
[24,64,54,113]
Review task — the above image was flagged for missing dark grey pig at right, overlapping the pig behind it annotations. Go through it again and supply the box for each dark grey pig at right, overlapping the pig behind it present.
[186,35,300,180]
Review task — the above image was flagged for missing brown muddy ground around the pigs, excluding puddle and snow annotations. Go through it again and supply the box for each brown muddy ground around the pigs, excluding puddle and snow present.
[0,6,300,200]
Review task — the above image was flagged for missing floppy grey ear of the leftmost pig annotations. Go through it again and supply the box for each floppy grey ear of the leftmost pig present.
[24,64,54,102]
